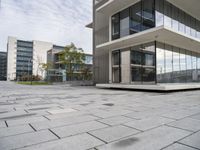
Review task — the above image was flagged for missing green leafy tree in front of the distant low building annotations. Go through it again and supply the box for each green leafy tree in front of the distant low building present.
[59,43,85,80]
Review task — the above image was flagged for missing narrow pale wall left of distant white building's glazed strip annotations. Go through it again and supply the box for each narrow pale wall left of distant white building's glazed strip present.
[7,37,17,81]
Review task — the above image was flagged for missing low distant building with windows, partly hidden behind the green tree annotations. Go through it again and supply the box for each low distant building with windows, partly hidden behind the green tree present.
[47,46,93,82]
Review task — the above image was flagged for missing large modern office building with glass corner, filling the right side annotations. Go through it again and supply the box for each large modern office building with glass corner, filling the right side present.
[88,0,200,89]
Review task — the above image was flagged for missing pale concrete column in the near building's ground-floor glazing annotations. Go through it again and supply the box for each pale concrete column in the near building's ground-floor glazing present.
[121,51,130,84]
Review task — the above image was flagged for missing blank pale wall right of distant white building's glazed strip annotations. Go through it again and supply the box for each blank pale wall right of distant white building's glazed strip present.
[33,41,53,78]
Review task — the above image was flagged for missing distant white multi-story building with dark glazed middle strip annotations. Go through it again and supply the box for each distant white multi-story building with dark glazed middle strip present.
[7,37,56,80]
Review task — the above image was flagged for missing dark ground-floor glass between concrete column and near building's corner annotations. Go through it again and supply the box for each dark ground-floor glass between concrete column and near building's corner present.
[130,42,155,84]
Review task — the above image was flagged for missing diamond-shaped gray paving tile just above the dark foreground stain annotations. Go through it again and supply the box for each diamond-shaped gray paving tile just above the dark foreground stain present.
[89,125,139,142]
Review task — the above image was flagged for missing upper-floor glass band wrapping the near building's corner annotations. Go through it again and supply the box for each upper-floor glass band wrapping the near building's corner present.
[111,0,200,40]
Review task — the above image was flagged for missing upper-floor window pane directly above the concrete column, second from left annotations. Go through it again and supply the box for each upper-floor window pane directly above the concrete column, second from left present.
[120,8,129,37]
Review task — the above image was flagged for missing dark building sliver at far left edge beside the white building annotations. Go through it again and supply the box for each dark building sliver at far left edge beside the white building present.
[0,52,7,81]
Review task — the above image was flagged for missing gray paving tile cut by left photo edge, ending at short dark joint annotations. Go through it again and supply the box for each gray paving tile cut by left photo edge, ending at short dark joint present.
[0,125,34,137]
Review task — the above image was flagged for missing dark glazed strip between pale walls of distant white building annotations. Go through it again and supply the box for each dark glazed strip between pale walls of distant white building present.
[16,40,33,79]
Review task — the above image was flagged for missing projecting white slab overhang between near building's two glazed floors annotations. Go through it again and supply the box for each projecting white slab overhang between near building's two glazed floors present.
[96,26,200,53]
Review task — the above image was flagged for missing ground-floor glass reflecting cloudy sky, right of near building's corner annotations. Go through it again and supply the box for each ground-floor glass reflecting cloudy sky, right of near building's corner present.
[156,42,200,83]
